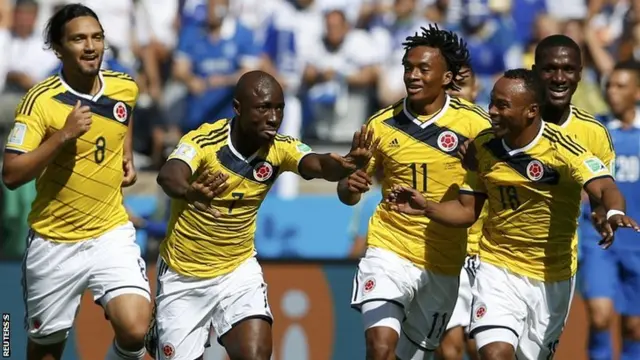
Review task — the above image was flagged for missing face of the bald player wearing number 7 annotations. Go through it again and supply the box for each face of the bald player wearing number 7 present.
[233,80,284,144]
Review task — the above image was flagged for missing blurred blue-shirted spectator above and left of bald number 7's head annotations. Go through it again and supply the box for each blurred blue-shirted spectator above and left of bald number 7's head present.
[173,0,259,132]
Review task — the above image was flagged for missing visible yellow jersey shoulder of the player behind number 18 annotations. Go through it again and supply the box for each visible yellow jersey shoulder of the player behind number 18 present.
[561,105,616,175]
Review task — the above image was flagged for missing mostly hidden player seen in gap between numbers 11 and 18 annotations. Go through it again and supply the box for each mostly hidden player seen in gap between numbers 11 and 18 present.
[436,66,486,360]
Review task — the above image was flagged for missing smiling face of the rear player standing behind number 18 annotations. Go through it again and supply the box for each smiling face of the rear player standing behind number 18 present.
[534,46,582,108]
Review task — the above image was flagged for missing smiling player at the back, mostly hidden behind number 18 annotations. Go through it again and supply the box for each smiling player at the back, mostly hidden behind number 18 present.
[533,35,615,222]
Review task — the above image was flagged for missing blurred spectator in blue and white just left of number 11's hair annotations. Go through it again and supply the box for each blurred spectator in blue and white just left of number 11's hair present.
[371,0,424,106]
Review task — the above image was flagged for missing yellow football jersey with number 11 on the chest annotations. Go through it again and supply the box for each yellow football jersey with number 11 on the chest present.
[367,97,491,275]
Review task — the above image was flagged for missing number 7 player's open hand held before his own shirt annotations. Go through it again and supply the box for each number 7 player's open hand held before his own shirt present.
[185,170,229,217]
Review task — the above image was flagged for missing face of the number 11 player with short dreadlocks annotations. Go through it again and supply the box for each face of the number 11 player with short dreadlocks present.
[402,46,453,107]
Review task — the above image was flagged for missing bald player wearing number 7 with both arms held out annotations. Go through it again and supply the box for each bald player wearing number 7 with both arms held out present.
[147,71,374,360]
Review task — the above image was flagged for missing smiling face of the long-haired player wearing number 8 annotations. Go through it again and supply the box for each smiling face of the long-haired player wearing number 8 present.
[54,16,105,76]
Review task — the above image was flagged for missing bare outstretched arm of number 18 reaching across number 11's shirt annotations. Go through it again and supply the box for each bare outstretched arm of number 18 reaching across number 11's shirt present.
[387,186,486,228]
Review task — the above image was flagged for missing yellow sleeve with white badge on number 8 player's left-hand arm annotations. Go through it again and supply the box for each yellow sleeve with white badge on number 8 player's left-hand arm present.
[5,97,47,153]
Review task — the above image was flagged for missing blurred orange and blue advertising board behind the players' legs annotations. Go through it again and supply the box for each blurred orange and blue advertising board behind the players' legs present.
[0,260,620,360]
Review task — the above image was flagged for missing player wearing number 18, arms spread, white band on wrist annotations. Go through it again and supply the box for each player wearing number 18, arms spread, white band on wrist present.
[389,69,640,360]
